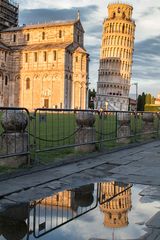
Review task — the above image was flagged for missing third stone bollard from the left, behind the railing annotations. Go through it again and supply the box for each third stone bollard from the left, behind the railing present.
[117,113,131,143]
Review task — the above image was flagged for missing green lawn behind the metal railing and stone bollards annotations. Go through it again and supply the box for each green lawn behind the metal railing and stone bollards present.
[0,111,158,172]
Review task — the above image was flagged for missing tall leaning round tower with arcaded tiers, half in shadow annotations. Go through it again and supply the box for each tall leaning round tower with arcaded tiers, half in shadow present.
[96,3,135,111]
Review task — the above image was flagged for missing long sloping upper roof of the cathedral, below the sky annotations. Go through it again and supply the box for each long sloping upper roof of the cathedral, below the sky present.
[1,19,80,32]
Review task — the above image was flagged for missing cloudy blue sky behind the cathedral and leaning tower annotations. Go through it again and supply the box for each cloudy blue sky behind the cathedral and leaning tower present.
[19,0,160,96]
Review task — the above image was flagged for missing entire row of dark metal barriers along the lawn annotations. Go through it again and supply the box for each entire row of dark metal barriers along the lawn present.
[0,108,160,166]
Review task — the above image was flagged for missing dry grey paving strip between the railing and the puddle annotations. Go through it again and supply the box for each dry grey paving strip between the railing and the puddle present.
[0,141,160,197]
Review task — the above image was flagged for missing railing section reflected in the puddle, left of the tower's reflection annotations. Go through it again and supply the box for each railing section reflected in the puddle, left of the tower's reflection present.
[33,184,98,238]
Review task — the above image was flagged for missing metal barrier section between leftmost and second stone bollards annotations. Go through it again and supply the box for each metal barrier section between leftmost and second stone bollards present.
[34,108,100,152]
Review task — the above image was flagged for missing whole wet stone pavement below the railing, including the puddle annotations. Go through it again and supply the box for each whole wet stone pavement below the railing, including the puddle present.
[0,141,160,240]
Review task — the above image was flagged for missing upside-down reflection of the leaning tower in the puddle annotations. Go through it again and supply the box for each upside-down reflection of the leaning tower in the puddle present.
[100,182,132,228]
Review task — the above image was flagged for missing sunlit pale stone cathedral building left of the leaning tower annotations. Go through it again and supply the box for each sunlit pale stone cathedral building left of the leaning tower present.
[0,0,89,110]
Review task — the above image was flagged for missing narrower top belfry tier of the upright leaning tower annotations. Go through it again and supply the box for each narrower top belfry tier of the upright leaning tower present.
[108,3,133,20]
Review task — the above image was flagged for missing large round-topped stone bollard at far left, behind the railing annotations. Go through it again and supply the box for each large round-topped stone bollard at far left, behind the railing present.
[0,110,29,168]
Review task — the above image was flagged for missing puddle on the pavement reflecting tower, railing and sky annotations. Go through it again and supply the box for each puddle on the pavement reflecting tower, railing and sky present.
[0,182,160,240]
